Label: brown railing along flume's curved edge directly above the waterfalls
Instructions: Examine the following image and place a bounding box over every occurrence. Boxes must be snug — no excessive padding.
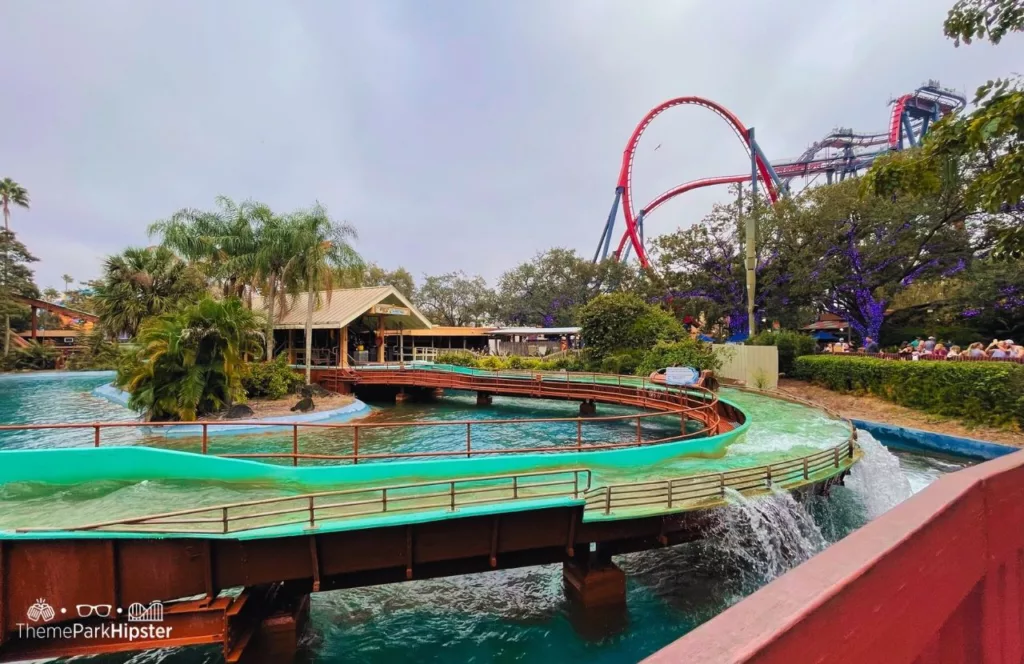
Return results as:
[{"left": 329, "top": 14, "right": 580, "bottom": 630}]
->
[{"left": 585, "top": 435, "right": 856, "bottom": 514}]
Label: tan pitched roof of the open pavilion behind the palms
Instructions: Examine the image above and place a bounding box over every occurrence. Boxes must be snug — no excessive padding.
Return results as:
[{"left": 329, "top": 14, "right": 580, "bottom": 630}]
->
[{"left": 253, "top": 286, "right": 430, "bottom": 330}]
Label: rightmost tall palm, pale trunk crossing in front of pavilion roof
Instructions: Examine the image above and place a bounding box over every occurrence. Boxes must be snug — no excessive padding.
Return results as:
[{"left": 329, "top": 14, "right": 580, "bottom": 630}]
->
[{"left": 290, "top": 203, "right": 362, "bottom": 384}]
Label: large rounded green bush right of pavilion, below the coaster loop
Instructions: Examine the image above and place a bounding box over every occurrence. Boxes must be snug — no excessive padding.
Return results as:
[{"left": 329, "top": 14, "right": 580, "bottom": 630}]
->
[{"left": 579, "top": 293, "right": 686, "bottom": 362}]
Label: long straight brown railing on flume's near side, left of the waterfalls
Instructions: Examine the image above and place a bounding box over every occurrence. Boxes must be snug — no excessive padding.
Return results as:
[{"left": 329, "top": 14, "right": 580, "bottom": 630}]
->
[{"left": 16, "top": 468, "right": 591, "bottom": 534}]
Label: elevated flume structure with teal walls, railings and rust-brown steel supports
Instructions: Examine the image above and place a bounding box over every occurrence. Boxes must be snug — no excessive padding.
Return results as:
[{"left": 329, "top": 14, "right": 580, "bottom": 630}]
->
[{"left": 0, "top": 367, "right": 860, "bottom": 662}]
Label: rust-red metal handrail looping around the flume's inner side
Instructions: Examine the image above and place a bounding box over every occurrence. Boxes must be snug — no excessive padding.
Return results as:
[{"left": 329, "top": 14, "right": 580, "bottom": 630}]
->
[{"left": 0, "top": 369, "right": 722, "bottom": 466}]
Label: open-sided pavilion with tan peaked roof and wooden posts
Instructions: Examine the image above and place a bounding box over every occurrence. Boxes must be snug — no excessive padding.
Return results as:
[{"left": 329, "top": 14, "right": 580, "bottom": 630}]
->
[{"left": 253, "top": 286, "right": 431, "bottom": 368}]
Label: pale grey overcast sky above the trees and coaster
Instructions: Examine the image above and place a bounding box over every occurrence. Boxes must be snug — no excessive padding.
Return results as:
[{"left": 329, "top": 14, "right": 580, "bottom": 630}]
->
[{"left": 0, "top": 0, "right": 1024, "bottom": 288}]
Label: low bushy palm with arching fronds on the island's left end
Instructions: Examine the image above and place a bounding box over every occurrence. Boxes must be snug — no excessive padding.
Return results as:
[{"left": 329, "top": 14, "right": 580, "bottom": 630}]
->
[{"left": 115, "top": 297, "right": 263, "bottom": 420}]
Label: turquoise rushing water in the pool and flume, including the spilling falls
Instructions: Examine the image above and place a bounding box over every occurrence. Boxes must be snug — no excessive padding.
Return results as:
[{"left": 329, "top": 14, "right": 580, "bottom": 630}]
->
[{"left": 0, "top": 376, "right": 967, "bottom": 664}]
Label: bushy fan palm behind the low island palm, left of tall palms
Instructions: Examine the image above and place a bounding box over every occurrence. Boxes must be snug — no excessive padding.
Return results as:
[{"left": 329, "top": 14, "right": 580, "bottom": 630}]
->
[{"left": 94, "top": 246, "right": 206, "bottom": 337}]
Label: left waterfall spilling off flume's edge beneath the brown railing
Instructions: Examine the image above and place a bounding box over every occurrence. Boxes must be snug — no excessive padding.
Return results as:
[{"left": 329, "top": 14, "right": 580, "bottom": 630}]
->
[{"left": 706, "top": 489, "right": 827, "bottom": 588}]
